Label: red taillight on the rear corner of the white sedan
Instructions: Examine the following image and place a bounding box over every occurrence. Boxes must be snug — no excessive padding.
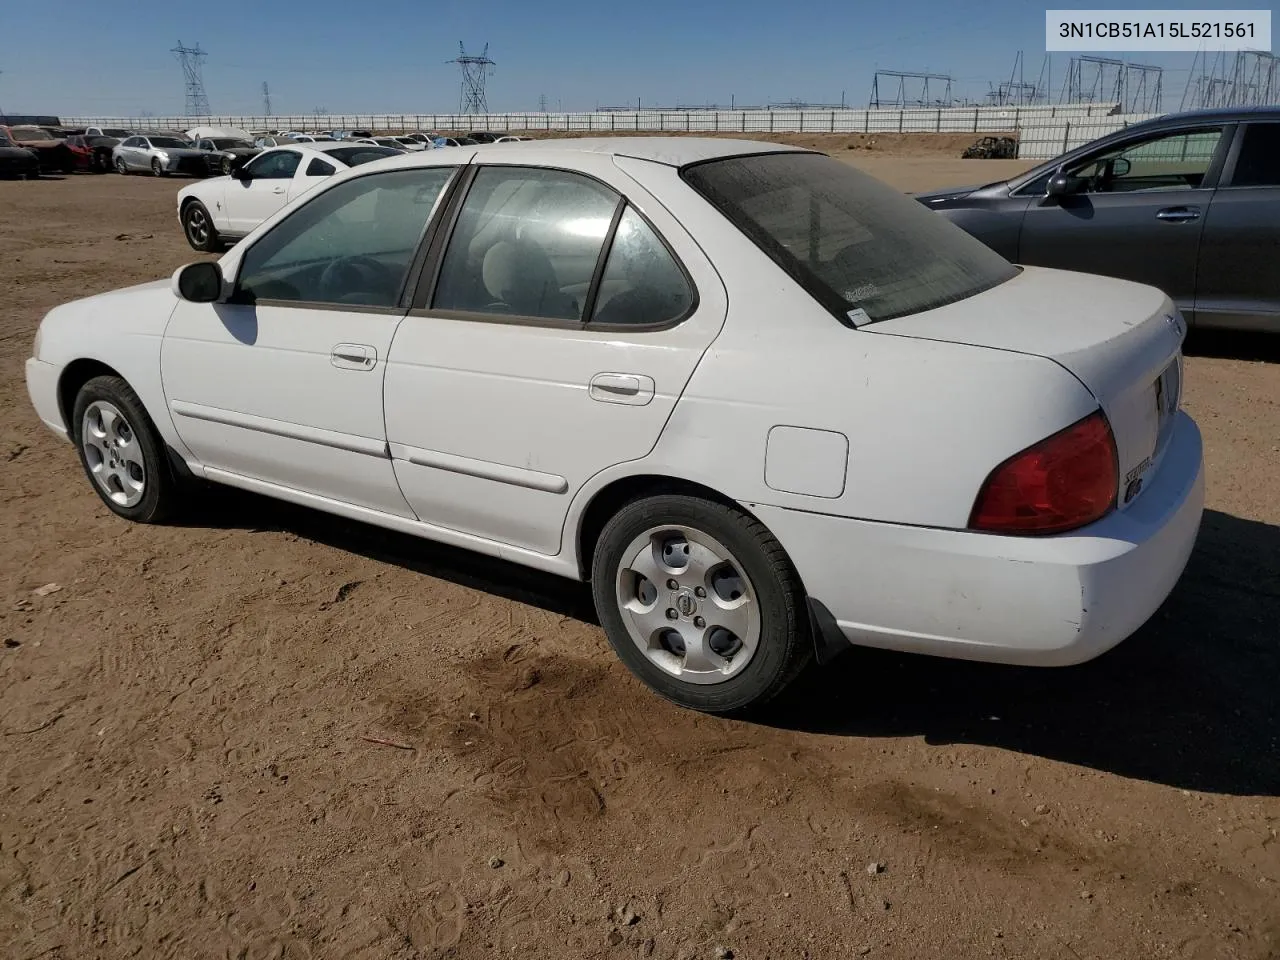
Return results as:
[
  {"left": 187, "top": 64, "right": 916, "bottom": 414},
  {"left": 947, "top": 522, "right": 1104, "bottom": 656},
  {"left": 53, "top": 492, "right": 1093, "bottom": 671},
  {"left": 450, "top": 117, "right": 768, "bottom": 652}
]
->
[{"left": 969, "top": 410, "right": 1119, "bottom": 534}]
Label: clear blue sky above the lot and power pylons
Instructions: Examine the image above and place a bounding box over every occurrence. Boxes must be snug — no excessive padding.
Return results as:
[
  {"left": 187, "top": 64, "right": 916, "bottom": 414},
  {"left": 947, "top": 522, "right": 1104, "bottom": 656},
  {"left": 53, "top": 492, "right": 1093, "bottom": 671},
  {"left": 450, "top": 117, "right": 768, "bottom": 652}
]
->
[{"left": 0, "top": 0, "right": 1247, "bottom": 116}]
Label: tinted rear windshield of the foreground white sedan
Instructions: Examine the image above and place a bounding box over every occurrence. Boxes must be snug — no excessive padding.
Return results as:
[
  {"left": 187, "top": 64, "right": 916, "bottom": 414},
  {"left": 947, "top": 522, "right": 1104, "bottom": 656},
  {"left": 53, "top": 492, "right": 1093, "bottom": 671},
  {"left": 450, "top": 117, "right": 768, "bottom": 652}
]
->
[{"left": 682, "top": 152, "right": 1018, "bottom": 326}]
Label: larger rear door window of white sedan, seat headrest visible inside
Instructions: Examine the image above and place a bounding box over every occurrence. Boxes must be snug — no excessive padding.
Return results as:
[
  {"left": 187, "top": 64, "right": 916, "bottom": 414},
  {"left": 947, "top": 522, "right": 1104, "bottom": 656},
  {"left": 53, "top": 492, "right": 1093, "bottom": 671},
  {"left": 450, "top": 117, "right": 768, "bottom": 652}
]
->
[{"left": 431, "top": 166, "right": 618, "bottom": 321}]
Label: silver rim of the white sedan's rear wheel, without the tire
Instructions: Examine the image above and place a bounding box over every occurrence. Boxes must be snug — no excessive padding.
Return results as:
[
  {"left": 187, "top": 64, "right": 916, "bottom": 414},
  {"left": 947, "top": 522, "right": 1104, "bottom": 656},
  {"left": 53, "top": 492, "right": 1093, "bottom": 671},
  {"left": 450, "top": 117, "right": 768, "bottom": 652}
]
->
[{"left": 617, "top": 526, "right": 760, "bottom": 684}]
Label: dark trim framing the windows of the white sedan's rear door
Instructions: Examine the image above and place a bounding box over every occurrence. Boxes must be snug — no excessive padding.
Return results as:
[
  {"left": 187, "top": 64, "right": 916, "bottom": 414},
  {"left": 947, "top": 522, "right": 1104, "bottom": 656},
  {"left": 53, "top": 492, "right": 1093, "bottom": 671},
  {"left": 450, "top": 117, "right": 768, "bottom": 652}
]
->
[{"left": 408, "top": 163, "right": 701, "bottom": 333}]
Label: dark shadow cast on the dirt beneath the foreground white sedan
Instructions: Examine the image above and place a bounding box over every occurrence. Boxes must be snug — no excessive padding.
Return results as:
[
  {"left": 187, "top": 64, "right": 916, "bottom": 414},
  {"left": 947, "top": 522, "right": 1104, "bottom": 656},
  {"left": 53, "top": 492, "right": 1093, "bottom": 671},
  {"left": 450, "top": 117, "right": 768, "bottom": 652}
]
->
[{"left": 185, "top": 490, "right": 1280, "bottom": 796}]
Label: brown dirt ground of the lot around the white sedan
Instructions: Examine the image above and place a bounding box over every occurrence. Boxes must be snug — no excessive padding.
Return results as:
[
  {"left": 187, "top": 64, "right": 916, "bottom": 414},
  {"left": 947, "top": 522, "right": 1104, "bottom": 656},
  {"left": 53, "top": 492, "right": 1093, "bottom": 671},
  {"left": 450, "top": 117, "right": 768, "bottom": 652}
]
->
[{"left": 0, "top": 140, "right": 1280, "bottom": 960}]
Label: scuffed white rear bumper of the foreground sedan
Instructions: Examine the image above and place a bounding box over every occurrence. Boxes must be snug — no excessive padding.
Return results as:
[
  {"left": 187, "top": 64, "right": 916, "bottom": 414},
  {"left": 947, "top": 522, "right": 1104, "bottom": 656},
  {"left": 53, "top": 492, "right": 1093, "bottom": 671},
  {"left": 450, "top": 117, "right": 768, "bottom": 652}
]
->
[{"left": 755, "top": 413, "right": 1204, "bottom": 667}]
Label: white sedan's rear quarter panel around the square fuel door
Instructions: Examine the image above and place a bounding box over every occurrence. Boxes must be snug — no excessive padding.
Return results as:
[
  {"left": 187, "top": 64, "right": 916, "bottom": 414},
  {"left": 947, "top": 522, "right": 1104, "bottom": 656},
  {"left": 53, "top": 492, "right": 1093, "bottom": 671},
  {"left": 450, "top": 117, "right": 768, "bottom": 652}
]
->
[{"left": 579, "top": 159, "right": 1097, "bottom": 527}]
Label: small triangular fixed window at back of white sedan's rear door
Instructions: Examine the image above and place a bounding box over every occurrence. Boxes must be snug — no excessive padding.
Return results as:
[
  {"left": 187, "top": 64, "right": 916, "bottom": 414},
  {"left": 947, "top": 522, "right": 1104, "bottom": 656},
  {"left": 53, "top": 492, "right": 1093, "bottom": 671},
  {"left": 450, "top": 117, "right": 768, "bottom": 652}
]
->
[{"left": 591, "top": 207, "right": 694, "bottom": 326}]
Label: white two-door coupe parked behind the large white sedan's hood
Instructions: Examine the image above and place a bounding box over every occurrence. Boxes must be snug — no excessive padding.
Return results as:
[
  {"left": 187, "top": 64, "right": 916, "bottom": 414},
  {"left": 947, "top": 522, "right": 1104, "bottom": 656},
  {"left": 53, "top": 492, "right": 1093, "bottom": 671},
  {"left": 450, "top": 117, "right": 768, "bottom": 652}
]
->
[{"left": 178, "top": 142, "right": 398, "bottom": 252}]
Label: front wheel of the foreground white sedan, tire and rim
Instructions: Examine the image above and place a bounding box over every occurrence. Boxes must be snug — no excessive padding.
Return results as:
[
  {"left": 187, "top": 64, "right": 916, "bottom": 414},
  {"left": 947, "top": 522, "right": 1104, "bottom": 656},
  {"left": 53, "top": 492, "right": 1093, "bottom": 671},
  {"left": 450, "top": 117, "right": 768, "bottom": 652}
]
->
[{"left": 72, "top": 376, "right": 179, "bottom": 524}]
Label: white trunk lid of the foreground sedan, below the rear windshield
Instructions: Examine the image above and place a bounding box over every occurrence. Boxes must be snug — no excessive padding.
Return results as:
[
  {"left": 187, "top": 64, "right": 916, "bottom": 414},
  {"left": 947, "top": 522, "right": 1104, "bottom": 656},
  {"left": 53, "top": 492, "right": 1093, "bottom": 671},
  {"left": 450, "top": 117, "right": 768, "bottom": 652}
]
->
[{"left": 861, "top": 266, "right": 1187, "bottom": 509}]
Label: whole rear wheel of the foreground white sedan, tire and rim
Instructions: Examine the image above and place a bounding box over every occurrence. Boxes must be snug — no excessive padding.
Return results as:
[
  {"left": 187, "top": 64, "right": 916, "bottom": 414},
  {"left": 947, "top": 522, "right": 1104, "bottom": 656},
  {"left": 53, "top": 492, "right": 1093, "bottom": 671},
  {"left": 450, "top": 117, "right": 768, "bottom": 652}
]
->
[{"left": 591, "top": 494, "right": 813, "bottom": 713}]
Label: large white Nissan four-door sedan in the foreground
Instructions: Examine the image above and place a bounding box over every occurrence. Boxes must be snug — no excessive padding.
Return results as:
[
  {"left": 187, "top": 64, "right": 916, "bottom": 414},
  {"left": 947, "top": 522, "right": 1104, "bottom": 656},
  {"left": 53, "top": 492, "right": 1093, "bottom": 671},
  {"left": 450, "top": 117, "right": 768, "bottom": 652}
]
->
[{"left": 27, "top": 138, "right": 1203, "bottom": 712}]
